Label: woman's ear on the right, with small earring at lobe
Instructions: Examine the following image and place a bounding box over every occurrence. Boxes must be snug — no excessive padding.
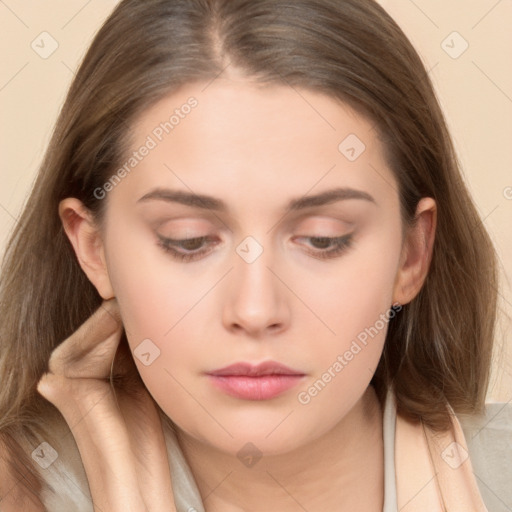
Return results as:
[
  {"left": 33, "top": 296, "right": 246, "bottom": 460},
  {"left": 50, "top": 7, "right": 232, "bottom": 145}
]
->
[{"left": 393, "top": 197, "right": 437, "bottom": 304}]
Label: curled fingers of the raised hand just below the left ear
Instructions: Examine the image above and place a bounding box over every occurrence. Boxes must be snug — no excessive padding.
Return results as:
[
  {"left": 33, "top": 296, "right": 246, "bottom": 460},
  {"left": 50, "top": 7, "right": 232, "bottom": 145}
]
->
[{"left": 49, "top": 298, "right": 122, "bottom": 378}]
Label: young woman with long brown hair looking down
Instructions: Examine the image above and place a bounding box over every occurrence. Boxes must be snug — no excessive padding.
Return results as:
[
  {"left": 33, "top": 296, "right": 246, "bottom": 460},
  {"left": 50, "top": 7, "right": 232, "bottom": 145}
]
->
[{"left": 0, "top": 0, "right": 512, "bottom": 512}]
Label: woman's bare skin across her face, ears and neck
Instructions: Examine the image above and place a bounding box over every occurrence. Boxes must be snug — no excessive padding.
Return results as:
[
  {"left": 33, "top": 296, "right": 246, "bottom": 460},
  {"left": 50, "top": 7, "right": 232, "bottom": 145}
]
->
[{"left": 59, "top": 78, "right": 436, "bottom": 512}]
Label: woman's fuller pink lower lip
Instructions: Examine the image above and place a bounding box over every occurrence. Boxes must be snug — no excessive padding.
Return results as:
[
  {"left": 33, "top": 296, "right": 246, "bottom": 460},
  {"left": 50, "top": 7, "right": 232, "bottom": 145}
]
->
[{"left": 208, "top": 375, "right": 304, "bottom": 400}]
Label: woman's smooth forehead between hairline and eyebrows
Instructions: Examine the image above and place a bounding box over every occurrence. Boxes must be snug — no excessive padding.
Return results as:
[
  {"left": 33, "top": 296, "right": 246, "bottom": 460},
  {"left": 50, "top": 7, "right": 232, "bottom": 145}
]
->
[{"left": 117, "top": 78, "right": 397, "bottom": 215}]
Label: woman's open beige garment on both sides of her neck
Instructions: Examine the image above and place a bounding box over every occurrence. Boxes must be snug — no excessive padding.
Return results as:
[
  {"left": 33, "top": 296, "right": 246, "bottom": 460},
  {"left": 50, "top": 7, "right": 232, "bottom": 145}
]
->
[{"left": 34, "top": 393, "right": 512, "bottom": 512}]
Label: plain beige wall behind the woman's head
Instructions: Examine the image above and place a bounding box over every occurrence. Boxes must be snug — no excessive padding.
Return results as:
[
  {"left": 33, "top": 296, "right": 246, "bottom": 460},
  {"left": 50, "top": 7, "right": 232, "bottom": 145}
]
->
[{"left": 0, "top": 0, "right": 512, "bottom": 401}]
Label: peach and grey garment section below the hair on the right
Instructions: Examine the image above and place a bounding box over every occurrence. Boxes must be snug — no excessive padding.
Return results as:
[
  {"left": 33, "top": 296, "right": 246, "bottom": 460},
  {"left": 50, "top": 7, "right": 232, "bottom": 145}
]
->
[{"left": 395, "top": 388, "right": 512, "bottom": 512}]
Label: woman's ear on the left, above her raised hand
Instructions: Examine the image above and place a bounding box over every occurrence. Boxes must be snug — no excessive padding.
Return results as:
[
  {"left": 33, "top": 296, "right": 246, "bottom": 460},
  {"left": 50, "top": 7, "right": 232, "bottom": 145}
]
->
[{"left": 59, "top": 197, "right": 115, "bottom": 300}]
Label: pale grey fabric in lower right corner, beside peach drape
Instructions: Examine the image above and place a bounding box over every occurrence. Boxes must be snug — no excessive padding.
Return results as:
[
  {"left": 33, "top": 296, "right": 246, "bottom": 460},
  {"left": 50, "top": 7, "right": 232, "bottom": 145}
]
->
[{"left": 458, "top": 402, "right": 512, "bottom": 511}]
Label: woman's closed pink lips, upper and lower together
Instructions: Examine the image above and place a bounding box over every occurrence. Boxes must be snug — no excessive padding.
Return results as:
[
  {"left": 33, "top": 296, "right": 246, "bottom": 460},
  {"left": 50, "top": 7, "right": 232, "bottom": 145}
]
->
[{"left": 207, "top": 361, "right": 305, "bottom": 400}]
